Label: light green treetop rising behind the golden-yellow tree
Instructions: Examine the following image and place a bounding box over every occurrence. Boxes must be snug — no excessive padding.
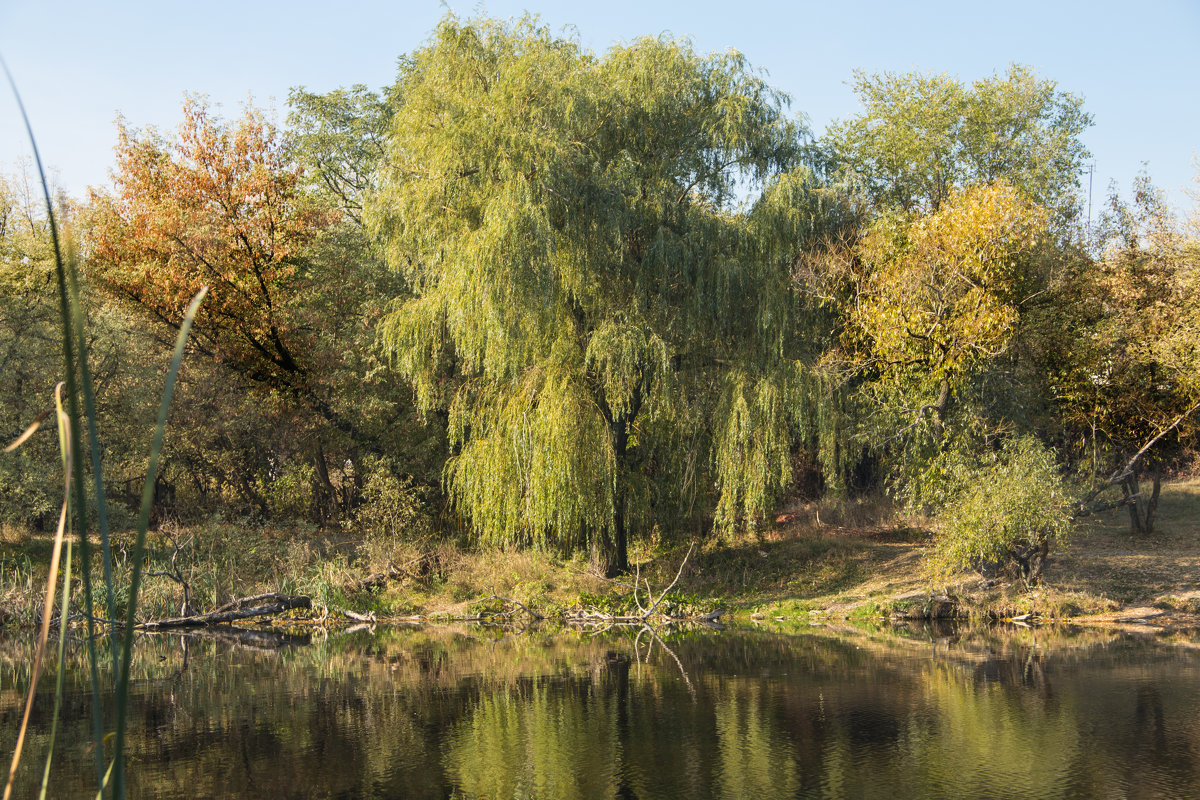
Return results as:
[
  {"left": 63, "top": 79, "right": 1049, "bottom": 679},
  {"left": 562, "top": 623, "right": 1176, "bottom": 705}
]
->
[{"left": 826, "top": 65, "right": 1092, "bottom": 222}]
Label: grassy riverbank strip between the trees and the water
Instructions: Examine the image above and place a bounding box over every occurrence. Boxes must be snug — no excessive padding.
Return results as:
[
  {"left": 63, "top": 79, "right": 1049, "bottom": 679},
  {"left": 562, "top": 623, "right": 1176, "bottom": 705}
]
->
[{"left": 0, "top": 479, "right": 1200, "bottom": 630}]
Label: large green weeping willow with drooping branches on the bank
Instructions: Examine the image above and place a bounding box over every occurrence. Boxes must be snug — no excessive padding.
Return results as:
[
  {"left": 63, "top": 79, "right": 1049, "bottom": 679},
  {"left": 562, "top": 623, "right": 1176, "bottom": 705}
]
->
[{"left": 367, "top": 17, "right": 820, "bottom": 573}]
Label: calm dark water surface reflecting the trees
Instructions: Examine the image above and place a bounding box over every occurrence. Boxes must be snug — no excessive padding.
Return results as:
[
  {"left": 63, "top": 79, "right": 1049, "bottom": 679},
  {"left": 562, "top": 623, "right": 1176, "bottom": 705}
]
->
[{"left": 0, "top": 627, "right": 1200, "bottom": 800}]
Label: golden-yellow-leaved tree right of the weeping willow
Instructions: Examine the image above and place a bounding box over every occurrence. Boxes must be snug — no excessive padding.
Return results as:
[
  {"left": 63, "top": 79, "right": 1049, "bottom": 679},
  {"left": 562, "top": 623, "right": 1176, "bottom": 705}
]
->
[{"left": 847, "top": 184, "right": 1046, "bottom": 503}]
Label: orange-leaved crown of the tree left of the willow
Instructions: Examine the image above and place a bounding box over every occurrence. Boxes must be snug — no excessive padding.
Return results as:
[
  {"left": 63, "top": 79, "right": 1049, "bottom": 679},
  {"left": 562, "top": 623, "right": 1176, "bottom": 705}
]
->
[{"left": 89, "top": 98, "right": 337, "bottom": 401}]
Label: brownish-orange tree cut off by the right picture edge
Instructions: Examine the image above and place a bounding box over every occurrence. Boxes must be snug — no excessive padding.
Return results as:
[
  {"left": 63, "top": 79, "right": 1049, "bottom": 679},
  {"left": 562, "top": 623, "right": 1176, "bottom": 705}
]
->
[{"left": 1054, "top": 175, "right": 1200, "bottom": 533}]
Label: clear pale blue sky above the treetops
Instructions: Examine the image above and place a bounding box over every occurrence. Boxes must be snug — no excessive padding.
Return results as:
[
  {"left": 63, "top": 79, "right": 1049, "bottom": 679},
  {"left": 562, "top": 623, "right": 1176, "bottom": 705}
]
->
[{"left": 0, "top": 0, "right": 1200, "bottom": 214}]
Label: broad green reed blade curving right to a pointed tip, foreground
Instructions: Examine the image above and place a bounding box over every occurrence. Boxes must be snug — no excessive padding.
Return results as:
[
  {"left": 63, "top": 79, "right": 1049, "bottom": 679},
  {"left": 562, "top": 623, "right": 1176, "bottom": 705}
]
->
[{"left": 113, "top": 287, "right": 209, "bottom": 798}]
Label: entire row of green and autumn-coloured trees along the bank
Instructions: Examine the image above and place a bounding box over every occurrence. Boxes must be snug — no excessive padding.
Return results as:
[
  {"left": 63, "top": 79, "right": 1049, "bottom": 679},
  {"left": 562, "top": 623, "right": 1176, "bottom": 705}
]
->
[{"left": 0, "top": 17, "right": 1200, "bottom": 579}]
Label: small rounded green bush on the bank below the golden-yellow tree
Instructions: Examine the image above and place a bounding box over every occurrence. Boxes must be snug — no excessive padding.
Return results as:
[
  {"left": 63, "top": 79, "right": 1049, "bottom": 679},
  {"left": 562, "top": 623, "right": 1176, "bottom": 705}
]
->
[{"left": 932, "top": 435, "right": 1070, "bottom": 585}]
